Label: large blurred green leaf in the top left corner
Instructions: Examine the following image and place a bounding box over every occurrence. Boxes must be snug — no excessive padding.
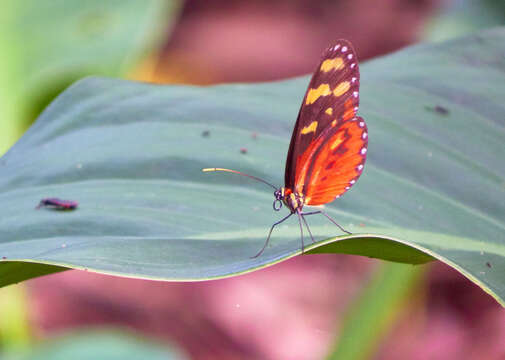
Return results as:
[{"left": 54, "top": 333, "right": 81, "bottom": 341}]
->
[{"left": 0, "top": 0, "right": 179, "bottom": 153}]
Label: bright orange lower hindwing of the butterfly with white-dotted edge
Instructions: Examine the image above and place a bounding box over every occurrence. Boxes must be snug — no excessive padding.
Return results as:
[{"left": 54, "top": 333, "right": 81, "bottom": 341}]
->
[{"left": 295, "top": 116, "right": 368, "bottom": 205}]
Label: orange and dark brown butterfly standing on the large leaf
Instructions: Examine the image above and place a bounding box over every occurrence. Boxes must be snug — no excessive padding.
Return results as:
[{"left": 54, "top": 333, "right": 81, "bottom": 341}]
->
[{"left": 202, "top": 39, "right": 368, "bottom": 258}]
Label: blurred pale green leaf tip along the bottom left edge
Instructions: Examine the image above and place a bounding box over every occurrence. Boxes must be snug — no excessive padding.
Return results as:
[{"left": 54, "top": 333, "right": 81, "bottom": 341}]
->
[{"left": 2, "top": 329, "right": 187, "bottom": 360}]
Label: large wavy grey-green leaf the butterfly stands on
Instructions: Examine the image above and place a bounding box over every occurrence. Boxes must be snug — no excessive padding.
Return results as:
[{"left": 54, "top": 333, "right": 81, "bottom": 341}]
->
[{"left": 0, "top": 28, "right": 505, "bottom": 304}]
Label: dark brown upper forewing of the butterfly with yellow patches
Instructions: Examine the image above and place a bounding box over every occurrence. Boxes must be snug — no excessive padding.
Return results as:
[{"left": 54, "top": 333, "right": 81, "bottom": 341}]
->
[{"left": 284, "top": 40, "right": 359, "bottom": 188}]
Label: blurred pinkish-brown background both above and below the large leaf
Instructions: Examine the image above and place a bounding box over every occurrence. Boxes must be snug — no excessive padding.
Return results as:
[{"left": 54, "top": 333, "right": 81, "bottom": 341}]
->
[{"left": 28, "top": 0, "right": 505, "bottom": 360}]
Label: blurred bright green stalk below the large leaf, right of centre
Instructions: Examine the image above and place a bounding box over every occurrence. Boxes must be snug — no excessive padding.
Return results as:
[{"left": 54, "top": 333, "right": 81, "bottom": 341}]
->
[{"left": 328, "top": 263, "right": 424, "bottom": 360}]
